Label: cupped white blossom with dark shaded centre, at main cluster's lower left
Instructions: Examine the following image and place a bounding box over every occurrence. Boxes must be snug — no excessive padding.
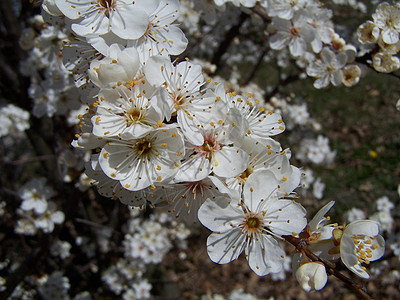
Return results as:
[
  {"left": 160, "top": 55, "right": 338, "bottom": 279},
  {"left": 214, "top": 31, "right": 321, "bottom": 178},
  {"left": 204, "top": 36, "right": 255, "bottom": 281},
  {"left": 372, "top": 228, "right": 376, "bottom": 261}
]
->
[{"left": 99, "top": 128, "right": 185, "bottom": 191}]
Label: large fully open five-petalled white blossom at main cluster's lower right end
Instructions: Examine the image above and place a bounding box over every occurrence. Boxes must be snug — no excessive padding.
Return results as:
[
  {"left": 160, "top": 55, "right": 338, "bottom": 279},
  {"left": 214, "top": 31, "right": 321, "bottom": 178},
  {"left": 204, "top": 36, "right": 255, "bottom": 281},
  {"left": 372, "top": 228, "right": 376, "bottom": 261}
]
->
[{"left": 198, "top": 170, "right": 306, "bottom": 276}]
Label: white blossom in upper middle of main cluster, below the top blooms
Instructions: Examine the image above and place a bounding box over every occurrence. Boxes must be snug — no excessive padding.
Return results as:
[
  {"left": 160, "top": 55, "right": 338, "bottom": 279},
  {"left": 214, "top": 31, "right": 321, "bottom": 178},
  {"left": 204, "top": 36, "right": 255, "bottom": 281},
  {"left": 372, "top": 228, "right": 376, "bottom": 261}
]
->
[{"left": 145, "top": 56, "right": 223, "bottom": 145}]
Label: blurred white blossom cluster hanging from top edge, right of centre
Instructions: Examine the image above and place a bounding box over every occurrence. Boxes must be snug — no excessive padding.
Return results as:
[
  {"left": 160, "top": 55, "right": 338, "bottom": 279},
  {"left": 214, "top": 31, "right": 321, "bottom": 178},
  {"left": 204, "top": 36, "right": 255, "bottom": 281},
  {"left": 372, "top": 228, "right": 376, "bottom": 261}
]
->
[{"left": 211, "top": 0, "right": 361, "bottom": 89}]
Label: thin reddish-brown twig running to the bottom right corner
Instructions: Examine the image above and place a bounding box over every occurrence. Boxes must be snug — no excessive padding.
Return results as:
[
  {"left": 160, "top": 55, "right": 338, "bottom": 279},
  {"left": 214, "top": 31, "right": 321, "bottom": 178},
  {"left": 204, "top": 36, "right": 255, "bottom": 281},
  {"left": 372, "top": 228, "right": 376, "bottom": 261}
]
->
[{"left": 283, "top": 235, "right": 371, "bottom": 300}]
